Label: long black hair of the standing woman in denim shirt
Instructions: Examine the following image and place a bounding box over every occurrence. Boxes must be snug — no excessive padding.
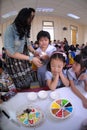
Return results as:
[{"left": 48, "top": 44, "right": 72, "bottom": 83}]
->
[{"left": 13, "top": 8, "right": 35, "bottom": 39}]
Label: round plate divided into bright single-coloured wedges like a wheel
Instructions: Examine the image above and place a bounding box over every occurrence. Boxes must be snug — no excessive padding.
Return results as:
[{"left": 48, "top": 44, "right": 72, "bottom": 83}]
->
[{"left": 50, "top": 99, "right": 73, "bottom": 119}]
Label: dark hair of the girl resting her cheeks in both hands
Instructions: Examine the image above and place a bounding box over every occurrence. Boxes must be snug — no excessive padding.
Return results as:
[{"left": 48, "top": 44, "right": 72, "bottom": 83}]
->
[{"left": 47, "top": 52, "right": 66, "bottom": 71}]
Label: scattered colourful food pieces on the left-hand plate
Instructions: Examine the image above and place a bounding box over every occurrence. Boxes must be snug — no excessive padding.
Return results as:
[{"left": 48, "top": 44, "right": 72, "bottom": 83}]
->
[{"left": 17, "top": 106, "right": 44, "bottom": 126}]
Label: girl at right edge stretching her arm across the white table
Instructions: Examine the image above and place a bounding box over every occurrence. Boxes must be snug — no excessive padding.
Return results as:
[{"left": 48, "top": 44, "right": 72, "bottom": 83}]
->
[{"left": 68, "top": 54, "right": 87, "bottom": 108}]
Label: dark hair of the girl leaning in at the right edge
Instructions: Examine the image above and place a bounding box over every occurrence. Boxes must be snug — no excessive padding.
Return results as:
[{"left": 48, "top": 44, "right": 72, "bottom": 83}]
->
[{"left": 74, "top": 54, "right": 87, "bottom": 69}]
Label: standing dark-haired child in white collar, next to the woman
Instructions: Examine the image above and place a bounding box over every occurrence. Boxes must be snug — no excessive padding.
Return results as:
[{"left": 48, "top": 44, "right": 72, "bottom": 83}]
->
[{"left": 36, "top": 31, "right": 56, "bottom": 87}]
